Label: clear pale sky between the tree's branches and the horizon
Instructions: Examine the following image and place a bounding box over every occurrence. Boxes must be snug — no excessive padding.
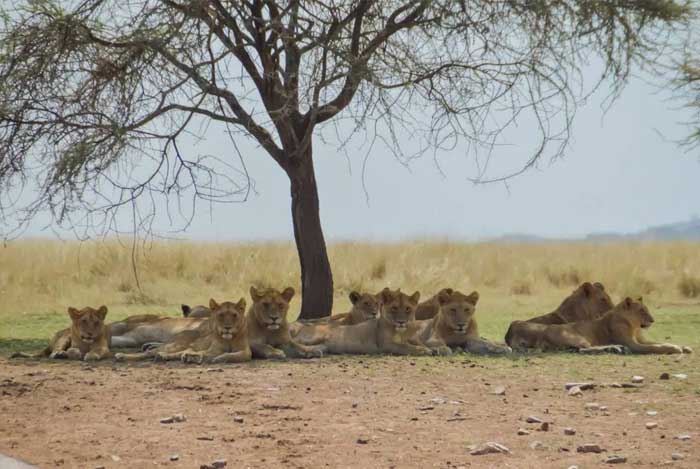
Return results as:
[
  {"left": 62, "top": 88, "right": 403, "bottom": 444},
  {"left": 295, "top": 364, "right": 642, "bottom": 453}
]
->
[{"left": 10, "top": 66, "right": 700, "bottom": 241}]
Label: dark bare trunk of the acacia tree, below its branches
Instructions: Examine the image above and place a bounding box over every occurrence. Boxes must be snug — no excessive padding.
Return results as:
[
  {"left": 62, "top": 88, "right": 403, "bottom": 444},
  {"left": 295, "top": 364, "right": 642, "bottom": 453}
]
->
[{"left": 287, "top": 146, "right": 333, "bottom": 319}]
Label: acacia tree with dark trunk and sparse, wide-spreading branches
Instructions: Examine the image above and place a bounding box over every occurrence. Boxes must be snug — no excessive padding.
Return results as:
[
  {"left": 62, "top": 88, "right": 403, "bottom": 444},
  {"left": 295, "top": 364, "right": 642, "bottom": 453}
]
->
[{"left": 0, "top": 0, "right": 689, "bottom": 318}]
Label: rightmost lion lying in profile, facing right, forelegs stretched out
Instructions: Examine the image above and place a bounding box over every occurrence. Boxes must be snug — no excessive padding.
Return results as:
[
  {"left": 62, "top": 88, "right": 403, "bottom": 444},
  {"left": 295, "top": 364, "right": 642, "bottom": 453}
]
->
[{"left": 506, "top": 297, "right": 692, "bottom": 354}]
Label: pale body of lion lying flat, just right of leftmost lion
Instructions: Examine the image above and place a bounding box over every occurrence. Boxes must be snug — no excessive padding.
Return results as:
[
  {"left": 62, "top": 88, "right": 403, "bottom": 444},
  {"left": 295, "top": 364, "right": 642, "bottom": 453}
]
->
[{"left": 110, "top": 314, "right": 206, "bottom": 348}]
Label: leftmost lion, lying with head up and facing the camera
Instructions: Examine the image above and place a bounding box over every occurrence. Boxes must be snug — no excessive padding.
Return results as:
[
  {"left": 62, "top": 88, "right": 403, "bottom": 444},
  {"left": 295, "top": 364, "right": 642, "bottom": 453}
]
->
[{"left": 12, "top": 305, "right": 112, "bottom": 361}]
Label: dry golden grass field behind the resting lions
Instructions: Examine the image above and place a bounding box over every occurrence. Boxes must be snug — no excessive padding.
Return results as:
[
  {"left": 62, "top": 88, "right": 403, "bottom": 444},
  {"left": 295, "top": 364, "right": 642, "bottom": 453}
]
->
[{"left": 0, "top": 240, "right": 700, "bottom": 354}]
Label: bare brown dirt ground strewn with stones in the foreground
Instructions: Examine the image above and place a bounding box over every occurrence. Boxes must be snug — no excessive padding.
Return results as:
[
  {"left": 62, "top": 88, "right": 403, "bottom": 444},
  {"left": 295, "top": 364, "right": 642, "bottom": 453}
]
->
[{"left": 0, "top": 354, "right": 700, "bottom": 469}]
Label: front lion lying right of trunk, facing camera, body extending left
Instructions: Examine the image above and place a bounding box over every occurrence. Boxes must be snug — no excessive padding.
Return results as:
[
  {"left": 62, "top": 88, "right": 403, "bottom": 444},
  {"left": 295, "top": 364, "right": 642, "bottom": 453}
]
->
[{"left": 322, "top": 288, "right": 433, "bottom": 355}]
